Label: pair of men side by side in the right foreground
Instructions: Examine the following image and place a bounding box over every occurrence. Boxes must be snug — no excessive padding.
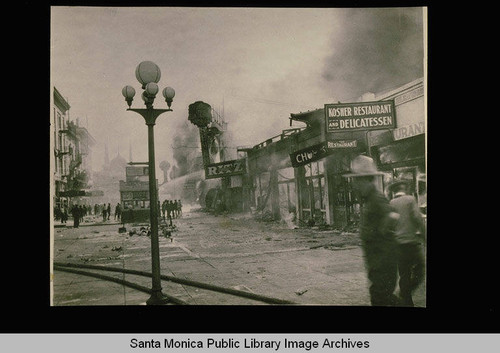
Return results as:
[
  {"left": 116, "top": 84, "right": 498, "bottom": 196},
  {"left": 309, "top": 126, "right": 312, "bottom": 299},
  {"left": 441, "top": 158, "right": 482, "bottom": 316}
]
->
[{"left": 344, "top": 155, "right": 426, "bottom": 307}]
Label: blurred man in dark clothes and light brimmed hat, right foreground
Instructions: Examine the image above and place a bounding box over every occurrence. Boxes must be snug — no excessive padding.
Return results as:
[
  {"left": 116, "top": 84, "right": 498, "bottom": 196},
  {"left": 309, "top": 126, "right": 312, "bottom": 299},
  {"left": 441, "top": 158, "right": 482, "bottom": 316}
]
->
[{"left": 343, "top": 155, "right": 399, "bottom": 306}]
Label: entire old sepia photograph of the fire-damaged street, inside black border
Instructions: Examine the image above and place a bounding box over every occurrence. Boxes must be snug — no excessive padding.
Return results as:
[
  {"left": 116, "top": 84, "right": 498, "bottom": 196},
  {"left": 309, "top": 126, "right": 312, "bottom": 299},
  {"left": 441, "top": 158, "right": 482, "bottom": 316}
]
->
[{"left": 48, "top": 6, "right": 428, "bottom": 310}]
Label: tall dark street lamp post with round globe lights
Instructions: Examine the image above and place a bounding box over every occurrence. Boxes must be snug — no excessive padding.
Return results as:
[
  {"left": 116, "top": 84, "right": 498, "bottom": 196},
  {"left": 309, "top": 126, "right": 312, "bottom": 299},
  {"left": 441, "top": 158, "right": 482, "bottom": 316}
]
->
[{"left": 122, "top": 61, "right": 175, "bottom": 305}]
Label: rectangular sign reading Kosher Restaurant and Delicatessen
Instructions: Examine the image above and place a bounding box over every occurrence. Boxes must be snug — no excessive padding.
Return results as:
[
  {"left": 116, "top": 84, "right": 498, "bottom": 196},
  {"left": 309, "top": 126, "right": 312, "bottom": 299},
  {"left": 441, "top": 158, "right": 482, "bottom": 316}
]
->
[{"left": 325, "top": 100, "right": 396, "bottom": 132}]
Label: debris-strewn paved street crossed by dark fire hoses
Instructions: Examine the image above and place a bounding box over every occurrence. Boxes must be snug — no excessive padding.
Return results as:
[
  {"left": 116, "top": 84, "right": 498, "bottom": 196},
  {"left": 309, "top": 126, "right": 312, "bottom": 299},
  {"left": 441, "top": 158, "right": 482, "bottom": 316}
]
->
[{"left": 53, "top": 210, "right": 425, "bottom": 307}]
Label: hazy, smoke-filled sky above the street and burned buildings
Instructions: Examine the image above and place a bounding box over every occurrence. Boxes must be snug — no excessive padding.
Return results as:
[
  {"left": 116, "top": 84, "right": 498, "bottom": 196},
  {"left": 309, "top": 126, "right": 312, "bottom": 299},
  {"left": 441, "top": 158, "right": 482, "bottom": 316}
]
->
[{"left": 50, "top": 6, "right": 425, "bottom": 175}]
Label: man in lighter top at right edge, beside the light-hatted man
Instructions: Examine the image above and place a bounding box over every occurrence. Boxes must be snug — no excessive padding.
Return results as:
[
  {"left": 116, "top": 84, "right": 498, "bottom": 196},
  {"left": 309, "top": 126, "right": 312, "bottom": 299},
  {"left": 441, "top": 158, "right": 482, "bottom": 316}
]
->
[{"left": 389, "top": 180, "right": 425, "bottom": 306}]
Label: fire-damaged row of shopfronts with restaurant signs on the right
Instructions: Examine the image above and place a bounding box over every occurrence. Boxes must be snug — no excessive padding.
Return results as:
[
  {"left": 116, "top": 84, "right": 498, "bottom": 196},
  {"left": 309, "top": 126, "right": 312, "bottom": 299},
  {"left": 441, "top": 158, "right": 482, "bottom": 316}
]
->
[{"left": 240, "top": 79, "right": 427, "bottom": 227}]
